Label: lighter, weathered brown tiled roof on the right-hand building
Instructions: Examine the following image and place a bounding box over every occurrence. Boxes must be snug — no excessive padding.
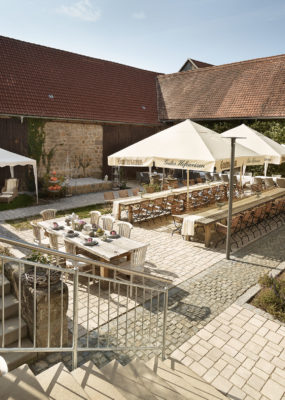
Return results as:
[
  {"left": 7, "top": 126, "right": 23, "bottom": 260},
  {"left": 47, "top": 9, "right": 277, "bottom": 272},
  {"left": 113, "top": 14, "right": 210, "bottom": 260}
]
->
[{"left": 158, "top": 55, "right": 285, "bottom": 121}]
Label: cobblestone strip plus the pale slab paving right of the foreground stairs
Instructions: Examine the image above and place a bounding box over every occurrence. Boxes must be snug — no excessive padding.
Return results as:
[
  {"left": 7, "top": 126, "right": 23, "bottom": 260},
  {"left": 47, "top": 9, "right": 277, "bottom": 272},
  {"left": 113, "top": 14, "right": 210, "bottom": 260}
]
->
[{"left": 27, "top": 226, "right": 285, "bottom": 400}]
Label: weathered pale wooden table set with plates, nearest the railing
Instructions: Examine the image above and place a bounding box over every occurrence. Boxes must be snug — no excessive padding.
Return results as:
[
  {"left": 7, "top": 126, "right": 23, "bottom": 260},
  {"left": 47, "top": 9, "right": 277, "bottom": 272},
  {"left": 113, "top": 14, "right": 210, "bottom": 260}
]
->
[{"left": 38, "top": 217, "right": 145, "bottom": 277}]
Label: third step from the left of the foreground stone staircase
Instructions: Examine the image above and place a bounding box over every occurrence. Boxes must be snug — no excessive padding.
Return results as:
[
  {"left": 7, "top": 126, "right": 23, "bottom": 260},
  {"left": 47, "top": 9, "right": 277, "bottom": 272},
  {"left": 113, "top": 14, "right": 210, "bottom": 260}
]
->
[{"left": 71, "top": 361, "right": 126, "bottom": 400}]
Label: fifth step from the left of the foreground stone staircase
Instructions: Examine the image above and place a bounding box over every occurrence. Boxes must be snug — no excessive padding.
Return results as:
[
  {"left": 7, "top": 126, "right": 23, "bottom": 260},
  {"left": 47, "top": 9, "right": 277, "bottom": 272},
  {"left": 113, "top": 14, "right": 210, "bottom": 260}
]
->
[{"left": 127, "top": 359, "right": 186, "bottom": 400}]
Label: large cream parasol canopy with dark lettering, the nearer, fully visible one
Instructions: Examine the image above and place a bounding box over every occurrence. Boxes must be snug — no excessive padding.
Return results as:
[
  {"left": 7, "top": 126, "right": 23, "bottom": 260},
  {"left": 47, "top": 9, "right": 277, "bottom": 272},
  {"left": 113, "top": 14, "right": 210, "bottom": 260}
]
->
[{"left": 108, "top": 119, "right": 264, "bottom": 172}]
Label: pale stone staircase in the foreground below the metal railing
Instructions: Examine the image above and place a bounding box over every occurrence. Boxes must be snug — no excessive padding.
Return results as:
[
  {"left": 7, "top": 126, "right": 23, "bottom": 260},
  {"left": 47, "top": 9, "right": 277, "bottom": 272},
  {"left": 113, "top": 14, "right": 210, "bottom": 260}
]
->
[{"left": 0, "top": 358, "right": 227, "bottom": 400}]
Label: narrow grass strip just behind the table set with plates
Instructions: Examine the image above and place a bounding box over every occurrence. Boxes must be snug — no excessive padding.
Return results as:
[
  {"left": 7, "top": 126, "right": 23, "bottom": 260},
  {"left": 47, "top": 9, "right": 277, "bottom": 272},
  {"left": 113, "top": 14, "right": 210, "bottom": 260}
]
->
[{"left": 7, "top": 204, "right": 110, "bottom": 231}]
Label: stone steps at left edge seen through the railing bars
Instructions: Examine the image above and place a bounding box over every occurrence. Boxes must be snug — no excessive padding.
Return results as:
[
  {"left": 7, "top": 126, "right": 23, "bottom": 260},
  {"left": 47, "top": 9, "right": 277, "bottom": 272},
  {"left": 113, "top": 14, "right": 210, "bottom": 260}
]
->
[{"left": 0, "top": 275, "right": 36, "bottom": 371}]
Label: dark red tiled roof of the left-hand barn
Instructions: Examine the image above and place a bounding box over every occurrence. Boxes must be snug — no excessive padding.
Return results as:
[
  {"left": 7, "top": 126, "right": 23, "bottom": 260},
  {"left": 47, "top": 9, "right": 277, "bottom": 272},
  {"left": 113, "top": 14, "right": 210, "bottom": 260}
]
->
[{"left": 0, "top": 36, "right": 158, "bottom": 124}]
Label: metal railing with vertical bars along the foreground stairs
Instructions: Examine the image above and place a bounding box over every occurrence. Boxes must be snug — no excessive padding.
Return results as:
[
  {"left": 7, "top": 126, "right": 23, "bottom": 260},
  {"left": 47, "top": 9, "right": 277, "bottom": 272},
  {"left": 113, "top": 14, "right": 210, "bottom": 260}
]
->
[{"left": 0, "top": 237, "right": 171, "bottom": 369}]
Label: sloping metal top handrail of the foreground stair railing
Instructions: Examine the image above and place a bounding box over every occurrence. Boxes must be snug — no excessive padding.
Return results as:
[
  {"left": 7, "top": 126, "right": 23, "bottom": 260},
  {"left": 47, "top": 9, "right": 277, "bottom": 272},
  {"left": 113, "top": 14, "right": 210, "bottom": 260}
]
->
[{"left": 0, "top": 236, "right": 173, "bottom": 285}]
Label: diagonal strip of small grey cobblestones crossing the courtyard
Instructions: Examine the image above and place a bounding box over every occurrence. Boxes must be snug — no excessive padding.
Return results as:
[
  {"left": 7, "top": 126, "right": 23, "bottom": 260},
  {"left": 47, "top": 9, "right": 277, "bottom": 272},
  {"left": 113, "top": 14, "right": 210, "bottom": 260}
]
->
[{"left": 28, "top": 223, "right": 285, "bottom": 382}]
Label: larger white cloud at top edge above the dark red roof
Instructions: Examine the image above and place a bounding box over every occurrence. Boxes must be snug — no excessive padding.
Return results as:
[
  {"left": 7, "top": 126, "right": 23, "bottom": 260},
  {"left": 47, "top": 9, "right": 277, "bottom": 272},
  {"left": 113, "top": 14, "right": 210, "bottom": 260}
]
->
[{"left": 56, "top": 0, "right": 101, "bottom": 22}]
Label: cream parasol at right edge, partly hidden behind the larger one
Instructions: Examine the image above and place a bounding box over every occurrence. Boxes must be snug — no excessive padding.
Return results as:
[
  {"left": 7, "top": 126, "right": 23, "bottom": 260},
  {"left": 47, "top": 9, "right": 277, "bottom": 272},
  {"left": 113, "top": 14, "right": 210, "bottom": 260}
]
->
[{"left": 223, "top": 124, "right": 285, "bottom": 176}]
